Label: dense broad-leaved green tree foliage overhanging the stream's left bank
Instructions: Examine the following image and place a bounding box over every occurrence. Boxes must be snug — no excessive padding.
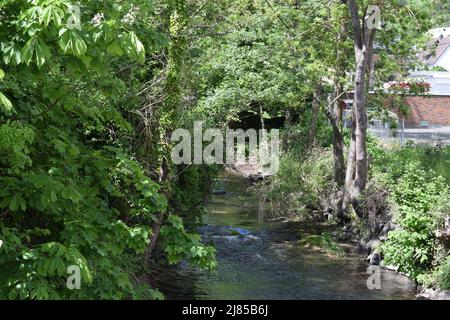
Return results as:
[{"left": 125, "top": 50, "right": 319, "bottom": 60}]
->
[{"left": 0, "top": 0, "right": 214, "bottom": 299}]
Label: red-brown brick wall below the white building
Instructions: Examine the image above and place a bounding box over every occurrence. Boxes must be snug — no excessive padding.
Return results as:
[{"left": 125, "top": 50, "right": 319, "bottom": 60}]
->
[{"left": 405, "top": 96, "right": 450, "bottom": 126}]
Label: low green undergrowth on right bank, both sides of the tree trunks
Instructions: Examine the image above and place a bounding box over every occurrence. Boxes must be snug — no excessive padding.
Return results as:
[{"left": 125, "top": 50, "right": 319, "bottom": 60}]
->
[{"left": 260, "top": 140, "right": 450, "bottom": 290}]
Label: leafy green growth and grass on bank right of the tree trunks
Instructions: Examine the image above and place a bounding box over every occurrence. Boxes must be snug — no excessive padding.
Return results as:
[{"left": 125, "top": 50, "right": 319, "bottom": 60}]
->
[{"left": 371, "top": 146, "right": 450, "bottom": 283}]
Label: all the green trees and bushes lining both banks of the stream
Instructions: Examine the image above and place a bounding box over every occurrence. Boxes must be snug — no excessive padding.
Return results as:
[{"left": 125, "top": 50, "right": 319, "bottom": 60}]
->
[{"left": 0, "top": 0, "right": 450, "bottom": 299}]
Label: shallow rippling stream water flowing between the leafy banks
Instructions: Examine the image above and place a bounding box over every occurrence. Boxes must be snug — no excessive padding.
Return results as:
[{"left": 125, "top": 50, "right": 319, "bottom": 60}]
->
[{"left": 153, "top": 176, "right": 414, "bottom": 300}]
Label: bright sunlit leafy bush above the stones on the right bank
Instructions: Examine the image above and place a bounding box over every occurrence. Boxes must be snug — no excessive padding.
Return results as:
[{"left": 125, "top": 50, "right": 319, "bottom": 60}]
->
[{"left": 382, "top": 162, "right": 449, "bottom": 279}]
